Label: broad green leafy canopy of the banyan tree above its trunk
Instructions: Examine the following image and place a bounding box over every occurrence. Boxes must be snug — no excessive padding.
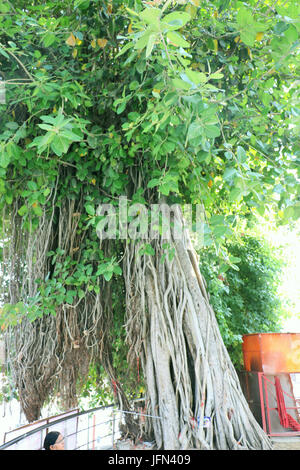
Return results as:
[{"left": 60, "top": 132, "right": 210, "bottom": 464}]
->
[{"left": 0, "top": 1, "right": 299, "bottom": 326}]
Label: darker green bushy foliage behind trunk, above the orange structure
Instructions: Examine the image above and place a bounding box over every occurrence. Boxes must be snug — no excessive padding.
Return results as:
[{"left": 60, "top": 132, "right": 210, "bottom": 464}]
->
[{"left": 201, "top": 234, "right": 286, "bottom": 369}]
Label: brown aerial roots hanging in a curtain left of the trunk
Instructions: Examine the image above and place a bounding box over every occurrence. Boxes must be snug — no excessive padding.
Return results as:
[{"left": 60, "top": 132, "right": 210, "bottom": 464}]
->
[{"left": 2, "top": 178, "right": 115, "bottom": 421}]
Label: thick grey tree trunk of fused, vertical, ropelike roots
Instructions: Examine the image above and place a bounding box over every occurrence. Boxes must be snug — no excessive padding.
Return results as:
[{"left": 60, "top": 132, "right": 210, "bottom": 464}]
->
[{"left": 124, "top": 207, "right": 272, "bottom": 450}]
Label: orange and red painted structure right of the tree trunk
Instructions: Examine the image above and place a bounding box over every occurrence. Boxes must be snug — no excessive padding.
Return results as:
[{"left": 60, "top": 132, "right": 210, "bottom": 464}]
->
[{"left": 243, "top": 333, "right": 300, "bottom": 436}]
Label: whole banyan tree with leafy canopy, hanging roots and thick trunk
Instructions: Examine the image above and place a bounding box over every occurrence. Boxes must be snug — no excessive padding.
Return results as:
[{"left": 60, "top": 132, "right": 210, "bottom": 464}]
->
[{"left": 0, "top": 0, "right": 299, "bottom": 450}]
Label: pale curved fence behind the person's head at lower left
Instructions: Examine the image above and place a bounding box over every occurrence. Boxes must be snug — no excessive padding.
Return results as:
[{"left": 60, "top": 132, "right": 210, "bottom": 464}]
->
[{"left": 0, "top": 405, "right": 161, "bottom": 450}]
